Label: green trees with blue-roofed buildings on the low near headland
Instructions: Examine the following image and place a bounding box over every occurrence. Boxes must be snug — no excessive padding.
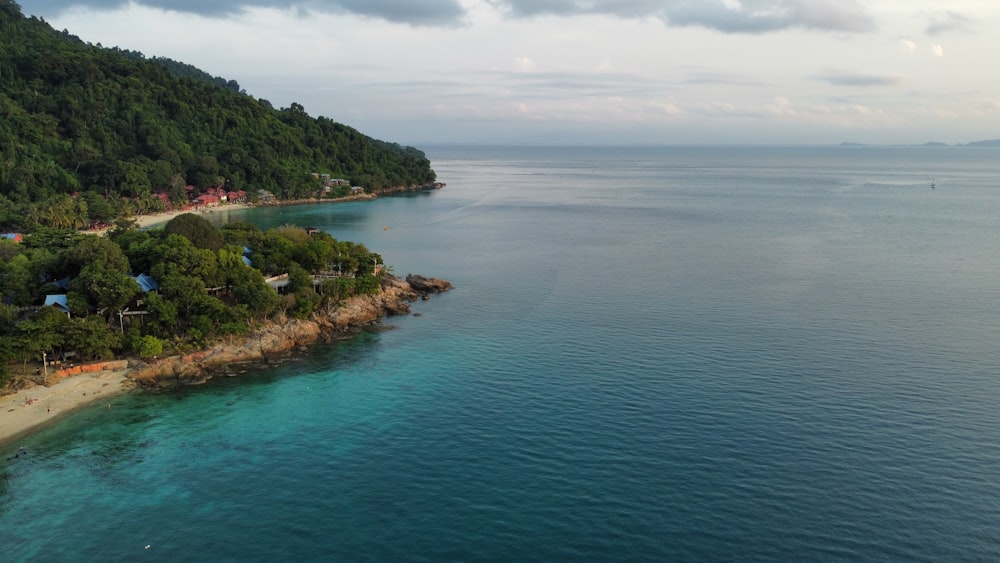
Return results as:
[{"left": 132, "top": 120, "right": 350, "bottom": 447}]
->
[{"left": 0, "top": 214, "right": 384, "bottom": 383}]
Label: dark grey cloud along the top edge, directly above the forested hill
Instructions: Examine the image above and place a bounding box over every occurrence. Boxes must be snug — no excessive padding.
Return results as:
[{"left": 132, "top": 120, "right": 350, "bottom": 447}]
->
[{"left": 20, "top": 0, "right": 465, "bottom": 25}]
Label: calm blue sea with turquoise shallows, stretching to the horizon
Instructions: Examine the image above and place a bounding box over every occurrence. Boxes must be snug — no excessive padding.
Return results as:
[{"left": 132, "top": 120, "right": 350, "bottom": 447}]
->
[{"left": 0, "top": 147, "right": 1000, "bottom": 561}]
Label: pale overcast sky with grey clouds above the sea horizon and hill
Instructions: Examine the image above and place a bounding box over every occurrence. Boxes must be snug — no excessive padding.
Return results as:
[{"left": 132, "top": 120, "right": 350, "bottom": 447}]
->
[{"left": 19, "top": 0, "right": 1000, "bottom": 146}]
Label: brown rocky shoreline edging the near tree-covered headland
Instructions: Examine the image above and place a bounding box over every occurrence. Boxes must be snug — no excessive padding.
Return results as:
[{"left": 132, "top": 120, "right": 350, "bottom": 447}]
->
[{"left": 128, "top": 274, "right": 452, "bottom": 388}]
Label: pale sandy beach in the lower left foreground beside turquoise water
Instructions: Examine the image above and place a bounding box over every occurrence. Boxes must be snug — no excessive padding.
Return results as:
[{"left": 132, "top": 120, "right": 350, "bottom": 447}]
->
[{"left": 0, "top": 370, "right": 132, "bottom": 447}]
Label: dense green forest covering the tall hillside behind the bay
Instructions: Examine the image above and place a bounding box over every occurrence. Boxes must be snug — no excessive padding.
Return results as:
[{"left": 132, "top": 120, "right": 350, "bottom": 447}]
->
[{"left": 0, "top": 0, "right": 435, "bottom": 233}]
